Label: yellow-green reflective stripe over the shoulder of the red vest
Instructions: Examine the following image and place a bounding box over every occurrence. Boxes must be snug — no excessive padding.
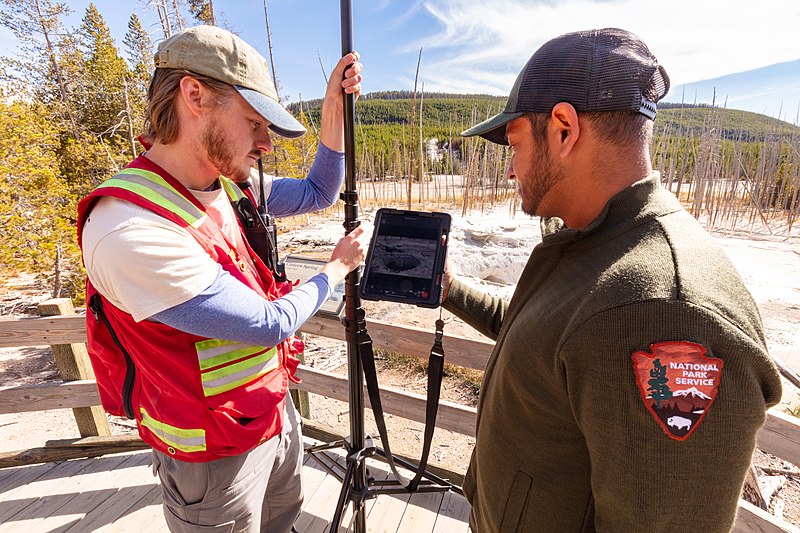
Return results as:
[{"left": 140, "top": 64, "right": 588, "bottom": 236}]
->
[{"left": 98, "top": 168, "right": 205, "bottom": 228}]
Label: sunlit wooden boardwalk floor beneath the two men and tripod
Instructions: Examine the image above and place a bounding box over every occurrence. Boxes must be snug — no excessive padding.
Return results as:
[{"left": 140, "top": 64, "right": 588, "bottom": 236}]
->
[{"left": 0, "top": 440, "right": 469, "bottom": 533}]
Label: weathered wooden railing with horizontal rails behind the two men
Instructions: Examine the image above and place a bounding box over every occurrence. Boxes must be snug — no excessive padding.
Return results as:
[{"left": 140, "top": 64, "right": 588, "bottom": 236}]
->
[{"left": 0, "top": 299, "right": 800, "bottom": 532}]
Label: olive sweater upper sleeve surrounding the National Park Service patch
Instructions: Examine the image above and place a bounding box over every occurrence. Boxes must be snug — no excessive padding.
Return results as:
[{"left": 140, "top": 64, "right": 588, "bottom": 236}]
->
[{"left": 558, "top": 301, "right": 781, "bottom": 532}]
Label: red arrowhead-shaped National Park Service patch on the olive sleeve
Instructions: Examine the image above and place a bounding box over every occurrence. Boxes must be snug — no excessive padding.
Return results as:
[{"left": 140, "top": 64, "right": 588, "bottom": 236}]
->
[{"left": 633, "top": 341, "right": 722, "bottom": 440}]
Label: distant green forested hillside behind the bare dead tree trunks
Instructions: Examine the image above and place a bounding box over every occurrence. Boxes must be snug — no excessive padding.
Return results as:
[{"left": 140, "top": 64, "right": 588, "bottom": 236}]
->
[{"left": 291, "top": 91, "right": 800, "bottom": 195}]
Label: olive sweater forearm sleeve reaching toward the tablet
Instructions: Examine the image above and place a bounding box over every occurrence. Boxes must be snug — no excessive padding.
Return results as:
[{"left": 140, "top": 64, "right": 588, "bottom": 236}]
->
[{"left": 442, "top": 278, "right": 508, "bottom": 340}]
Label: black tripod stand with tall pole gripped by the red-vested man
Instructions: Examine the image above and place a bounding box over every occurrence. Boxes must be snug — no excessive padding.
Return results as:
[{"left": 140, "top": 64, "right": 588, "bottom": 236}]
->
[{"left": 307, "top": 0, "right": 461, "bottom": 533}]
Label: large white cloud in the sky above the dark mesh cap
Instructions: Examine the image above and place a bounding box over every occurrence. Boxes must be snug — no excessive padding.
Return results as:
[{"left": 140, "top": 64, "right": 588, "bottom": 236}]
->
[{"left": 408, "top": 0, "right": 800, "bottom": 94}]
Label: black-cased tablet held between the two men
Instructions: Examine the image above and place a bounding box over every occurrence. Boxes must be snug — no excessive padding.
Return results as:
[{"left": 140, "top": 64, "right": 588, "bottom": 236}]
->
[{"left": 359, "top": 208, "right": 450, "bottom": 307}]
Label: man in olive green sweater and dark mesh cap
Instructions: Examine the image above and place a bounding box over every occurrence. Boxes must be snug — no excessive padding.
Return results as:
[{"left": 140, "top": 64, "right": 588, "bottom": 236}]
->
[{"left": 445, "top": 29, "right": 781, "bottom": 533}]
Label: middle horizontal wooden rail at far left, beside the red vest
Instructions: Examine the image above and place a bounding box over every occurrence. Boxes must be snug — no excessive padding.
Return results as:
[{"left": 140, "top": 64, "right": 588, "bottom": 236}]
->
[{"left": 0, "top": 380, "right": 100, "bottom": 414}]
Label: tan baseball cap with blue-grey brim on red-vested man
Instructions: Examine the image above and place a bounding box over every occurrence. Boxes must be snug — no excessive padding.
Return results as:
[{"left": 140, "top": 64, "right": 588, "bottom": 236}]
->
[{"left": 154, "top": 26, "right": 306, "bottom": 137}]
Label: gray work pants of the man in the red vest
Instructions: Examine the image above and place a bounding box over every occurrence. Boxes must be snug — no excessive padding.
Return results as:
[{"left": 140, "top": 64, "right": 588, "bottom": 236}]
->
[{"left": 153, "top": 394, "right": 303, "bottom": 533}]
